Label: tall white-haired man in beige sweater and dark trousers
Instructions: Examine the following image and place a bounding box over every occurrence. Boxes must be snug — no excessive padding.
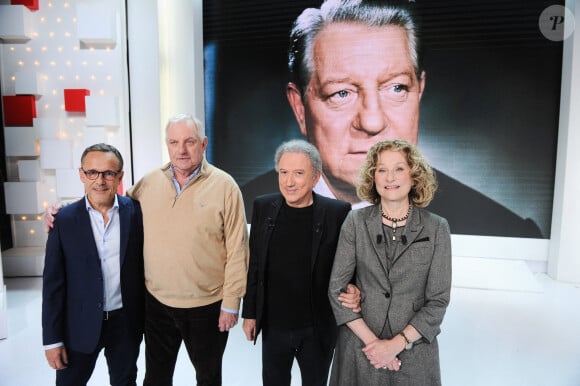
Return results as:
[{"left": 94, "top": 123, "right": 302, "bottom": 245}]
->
[{"left": 127, "top": 115, "right": 249, "bottom": 386}]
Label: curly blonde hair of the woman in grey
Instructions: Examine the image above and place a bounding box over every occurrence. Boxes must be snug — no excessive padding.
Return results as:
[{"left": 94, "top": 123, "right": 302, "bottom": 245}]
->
[{"left": 356, "top": 139, "right": 437, "bottom": 208}]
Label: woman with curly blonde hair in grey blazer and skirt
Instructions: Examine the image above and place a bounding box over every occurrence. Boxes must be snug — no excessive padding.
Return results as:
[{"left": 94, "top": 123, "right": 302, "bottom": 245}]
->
[{"left": 329, "top": 140, "right": 451, "bottom": 386}]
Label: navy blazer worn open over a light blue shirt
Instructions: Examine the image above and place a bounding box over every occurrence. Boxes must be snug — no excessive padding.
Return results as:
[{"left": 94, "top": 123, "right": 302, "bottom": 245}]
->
[{"left": 42, "top": 196, "right": 145, "bottom": 353}]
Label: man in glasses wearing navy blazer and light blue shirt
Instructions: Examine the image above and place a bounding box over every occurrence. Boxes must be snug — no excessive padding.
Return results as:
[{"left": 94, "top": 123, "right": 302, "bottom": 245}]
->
[{"left": 42, "top": 144, "right": 144, "bottom": 386}]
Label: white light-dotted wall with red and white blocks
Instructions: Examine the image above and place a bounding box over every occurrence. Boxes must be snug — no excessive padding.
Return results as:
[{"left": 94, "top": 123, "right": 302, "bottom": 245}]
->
[{"left": 0, "top": 0, "right": 133, "bottom": 276}]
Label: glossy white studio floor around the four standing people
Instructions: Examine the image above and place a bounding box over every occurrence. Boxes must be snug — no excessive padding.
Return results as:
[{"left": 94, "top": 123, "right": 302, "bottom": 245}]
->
[{"left": 0, "top": 259, "right": 580, "bottom": 386}]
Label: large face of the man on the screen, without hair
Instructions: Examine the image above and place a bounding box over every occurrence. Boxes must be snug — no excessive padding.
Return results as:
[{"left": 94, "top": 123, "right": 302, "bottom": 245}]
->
[{"left": 288, "top": 23, "right": 425, "bottom": 202}]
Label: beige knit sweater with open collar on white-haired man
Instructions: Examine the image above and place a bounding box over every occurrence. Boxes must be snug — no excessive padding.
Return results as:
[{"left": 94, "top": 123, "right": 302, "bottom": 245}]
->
[{"left": 127, "top": 159, "right": 249, "bottom": 310}]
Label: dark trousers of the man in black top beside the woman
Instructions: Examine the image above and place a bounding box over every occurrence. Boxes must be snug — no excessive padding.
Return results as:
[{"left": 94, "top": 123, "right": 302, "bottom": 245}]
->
[{"left": 262, "top": 326, "right": 334, "bottom": 386}]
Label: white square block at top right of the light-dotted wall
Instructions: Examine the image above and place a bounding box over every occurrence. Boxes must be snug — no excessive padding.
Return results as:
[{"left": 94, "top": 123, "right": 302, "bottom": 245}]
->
[{"left": 76, "top": 4, "right": 117, "bottom": 49}]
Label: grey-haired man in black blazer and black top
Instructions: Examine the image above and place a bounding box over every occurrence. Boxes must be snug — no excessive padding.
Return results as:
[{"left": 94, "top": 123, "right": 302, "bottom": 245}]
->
[{"left": 242, "top": 140, "right": 360, "bottom": 386}]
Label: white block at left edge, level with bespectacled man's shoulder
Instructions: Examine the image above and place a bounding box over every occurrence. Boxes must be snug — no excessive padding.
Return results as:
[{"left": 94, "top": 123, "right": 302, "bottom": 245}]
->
[{"left": 4, "top": 182, "right": 44, "bottom": 214}]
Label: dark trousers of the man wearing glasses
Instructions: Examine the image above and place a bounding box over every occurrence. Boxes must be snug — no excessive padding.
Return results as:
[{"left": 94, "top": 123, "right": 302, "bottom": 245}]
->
[{"left": 56, "top": 310, "right": 143, "bottom": 386}]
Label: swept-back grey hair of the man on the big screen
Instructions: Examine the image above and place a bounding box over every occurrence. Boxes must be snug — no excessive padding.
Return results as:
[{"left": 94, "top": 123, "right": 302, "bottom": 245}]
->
[{"left": 288, "top": 0, "right": 421, "bottom": 95}]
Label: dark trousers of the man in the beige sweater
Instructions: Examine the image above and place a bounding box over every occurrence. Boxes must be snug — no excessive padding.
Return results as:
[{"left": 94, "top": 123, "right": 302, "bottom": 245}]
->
[{"left": 143, "top": 292, "right": 228, "bottom": 386}]
